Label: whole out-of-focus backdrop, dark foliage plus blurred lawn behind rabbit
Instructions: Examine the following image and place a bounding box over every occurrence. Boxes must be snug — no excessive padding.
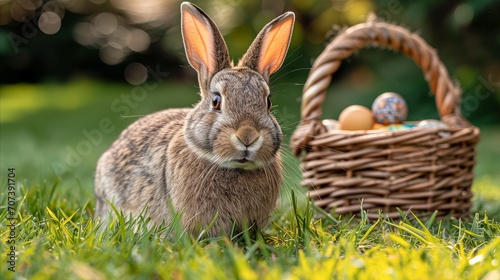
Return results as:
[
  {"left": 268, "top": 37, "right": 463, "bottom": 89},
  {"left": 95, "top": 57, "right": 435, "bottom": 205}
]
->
[{"left": 0, "top": 0, "right": 500, "bottom": 214}]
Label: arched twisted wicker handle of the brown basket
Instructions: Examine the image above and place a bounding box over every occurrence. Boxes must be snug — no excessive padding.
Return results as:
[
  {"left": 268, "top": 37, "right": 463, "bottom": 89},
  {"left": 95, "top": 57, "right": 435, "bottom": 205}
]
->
[{"left": 291, "top": 15, "right": 470, "bottom": 155}]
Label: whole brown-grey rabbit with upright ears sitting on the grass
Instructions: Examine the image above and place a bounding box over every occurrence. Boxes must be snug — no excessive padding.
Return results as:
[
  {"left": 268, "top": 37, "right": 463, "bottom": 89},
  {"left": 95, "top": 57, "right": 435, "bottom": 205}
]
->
[{"left": 94, "top": 2, "right": 295, "bottom": 237}]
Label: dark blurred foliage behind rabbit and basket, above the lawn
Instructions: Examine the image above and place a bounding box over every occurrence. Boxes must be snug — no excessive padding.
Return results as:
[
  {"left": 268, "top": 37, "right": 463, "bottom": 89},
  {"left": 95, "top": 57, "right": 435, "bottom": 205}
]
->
[{"left": 0, "top": 0, "right": 500, "bottom": 122}]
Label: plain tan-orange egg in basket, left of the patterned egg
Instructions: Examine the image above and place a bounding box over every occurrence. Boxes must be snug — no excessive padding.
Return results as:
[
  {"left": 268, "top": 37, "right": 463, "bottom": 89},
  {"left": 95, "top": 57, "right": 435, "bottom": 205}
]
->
[{"left": 339, "top": 105, "right": 373, "bottom": 130}]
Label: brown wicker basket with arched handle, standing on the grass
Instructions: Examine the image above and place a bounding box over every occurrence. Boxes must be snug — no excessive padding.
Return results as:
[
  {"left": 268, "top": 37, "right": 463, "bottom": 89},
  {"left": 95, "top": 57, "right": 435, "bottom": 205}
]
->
[{"left": 291, "top": 17, "right": 479, "bottom": 218}]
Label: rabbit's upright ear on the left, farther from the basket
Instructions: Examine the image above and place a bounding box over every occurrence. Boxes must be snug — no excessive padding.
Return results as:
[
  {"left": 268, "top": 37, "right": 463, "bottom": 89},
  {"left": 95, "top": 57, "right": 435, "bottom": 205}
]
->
[{"left": 181, "top": 2, "right": 231, "bottom": 91}]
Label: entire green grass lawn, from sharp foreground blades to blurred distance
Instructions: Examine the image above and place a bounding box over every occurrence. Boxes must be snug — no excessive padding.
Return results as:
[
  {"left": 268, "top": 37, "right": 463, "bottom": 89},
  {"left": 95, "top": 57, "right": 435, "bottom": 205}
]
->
[{"left": 0, "top": 80, "right": 500, "bottom": 280}]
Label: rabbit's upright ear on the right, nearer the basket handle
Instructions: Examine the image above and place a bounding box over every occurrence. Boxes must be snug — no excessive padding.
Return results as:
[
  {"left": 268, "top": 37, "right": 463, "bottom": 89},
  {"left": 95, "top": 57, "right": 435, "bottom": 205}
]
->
[{"left": 238, "top": 12, "right": 295, "bottom": 81}]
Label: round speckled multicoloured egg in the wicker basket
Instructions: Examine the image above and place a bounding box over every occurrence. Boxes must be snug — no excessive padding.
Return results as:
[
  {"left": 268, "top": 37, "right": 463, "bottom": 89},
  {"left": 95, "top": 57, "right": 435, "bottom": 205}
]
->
[{"left": 372, "top": 92, "right": 408, "bottom": 125}]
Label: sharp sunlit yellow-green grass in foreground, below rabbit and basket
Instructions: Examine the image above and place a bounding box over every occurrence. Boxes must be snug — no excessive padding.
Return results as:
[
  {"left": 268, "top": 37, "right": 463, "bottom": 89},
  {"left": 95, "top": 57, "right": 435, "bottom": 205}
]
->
[{"left": 0, "top": 180, "right": 500, "bottom": 279}]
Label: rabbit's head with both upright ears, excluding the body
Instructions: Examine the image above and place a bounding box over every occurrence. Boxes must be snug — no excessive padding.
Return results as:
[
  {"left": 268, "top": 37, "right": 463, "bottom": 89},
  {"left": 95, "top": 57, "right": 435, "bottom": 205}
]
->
[{"left": 181, "top": 2, "right": 295, "bottom": 170}]
